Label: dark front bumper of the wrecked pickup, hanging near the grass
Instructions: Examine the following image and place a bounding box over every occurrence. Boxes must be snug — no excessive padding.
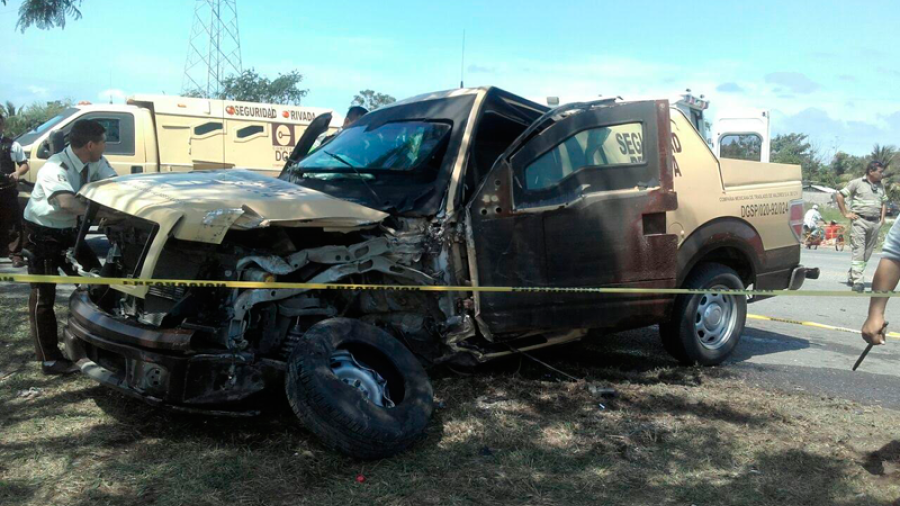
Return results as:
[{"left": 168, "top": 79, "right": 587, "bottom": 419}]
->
[{"left": 63, "top": 290, "right": 284, "bottom": 414}]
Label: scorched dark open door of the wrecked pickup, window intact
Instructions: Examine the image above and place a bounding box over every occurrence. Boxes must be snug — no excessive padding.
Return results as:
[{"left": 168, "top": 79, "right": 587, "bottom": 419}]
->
[{"left": 468, "top": 101, "right": 677, "bottom": 335}]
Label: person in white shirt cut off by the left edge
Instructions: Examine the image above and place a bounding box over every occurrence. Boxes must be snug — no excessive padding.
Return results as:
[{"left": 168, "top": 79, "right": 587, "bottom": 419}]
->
[{"left": 0, "top": 114, "right": 28, "bottom": 267}]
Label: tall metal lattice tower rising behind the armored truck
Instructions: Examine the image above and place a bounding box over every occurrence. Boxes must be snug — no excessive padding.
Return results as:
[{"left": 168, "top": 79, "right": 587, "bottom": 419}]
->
[{"left": 181, "top": 0, "right": 242, "bottom": 97}]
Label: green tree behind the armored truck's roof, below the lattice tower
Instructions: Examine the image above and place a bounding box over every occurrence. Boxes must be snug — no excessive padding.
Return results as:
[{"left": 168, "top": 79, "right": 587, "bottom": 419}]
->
[{"left": 184, "top": 68, "right": 309, "bottom": 105}]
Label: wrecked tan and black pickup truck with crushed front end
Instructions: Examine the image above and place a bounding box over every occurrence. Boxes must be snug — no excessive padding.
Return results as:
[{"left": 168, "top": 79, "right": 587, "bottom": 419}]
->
[{"left": 64, "top": 88, "right": 809, "bottom": 458}]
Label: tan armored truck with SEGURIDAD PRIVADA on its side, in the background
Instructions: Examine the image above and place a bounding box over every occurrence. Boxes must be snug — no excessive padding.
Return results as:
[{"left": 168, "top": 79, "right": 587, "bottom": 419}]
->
[{"left": 16, "top": 95, "right": 340, "bottom": 198}]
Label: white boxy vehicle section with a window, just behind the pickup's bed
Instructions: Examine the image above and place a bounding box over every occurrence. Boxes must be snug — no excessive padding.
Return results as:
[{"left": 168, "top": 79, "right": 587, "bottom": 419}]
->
[{"left": 713, "top": 109, "right": 771, "bottom": 163}]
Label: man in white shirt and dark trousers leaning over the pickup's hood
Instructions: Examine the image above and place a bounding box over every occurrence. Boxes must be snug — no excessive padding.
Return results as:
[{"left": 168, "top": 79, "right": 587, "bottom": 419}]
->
[{"left": 25, "top": 120, "right": 117, "bottom": 374}]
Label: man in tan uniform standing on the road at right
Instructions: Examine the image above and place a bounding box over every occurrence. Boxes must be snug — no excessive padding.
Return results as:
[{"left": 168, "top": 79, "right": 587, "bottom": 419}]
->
[{"left": 837, "top": 161, "right": 887, "bottom": 292}]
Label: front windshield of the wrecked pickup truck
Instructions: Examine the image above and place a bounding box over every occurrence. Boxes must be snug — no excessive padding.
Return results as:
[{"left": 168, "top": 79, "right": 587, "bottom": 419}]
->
[{"left": 290, "top": 121, "right": 450, "bottom": 179}]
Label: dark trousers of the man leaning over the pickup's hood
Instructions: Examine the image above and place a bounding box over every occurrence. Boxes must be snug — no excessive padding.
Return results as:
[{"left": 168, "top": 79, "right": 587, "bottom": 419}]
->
[{"left": 25, "top": 221, "right": 76, "bottom": 361}]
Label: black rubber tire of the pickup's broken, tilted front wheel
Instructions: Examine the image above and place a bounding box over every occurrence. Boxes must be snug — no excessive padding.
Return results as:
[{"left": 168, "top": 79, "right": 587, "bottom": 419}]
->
[{"left": 285, "top": 318, "right": 434, "bottom": 460}]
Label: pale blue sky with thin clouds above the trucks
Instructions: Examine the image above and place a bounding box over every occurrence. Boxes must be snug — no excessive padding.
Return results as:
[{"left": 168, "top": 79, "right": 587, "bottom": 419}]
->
[{"left": 0, "top": 0, "right": 900, "bottom": 156}]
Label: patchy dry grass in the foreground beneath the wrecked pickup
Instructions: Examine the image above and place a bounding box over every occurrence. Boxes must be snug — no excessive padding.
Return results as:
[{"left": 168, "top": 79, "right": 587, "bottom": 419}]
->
[{"left": 0, "top": 299, "right": 900, "bottom": 506}]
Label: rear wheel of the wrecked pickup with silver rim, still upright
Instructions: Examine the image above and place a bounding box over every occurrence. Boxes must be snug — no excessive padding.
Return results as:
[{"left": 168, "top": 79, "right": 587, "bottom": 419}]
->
[{"left": 659, "top": 264, "right": 747, "bottom": 365}]
